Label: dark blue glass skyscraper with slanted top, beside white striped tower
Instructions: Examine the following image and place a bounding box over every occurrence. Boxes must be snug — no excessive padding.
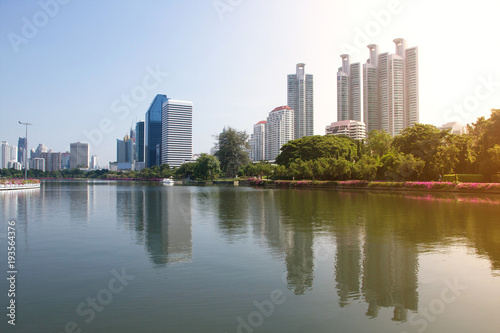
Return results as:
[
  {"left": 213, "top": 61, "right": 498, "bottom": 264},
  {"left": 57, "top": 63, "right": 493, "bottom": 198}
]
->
[{"left": 144, "top": 95, "right": 167, "bottom": 168}]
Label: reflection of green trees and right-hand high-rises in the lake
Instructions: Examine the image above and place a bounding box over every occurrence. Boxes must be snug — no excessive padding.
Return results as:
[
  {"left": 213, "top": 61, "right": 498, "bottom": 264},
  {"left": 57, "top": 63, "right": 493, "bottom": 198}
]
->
[{"left": 205, "top": 190, "right": 500, "bottom": 321}]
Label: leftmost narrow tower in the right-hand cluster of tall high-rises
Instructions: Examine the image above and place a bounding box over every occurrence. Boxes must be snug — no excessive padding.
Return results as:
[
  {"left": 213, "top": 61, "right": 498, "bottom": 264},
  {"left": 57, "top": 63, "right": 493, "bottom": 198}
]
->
[{"left": 337, "top": 54, "right": 361, "bottom": 121}]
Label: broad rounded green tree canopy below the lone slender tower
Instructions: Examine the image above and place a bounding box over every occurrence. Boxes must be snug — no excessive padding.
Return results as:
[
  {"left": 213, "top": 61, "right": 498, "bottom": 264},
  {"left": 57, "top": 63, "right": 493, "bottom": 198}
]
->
[{"left": 276, "top": 135, "right": 357, "bottom": 167}]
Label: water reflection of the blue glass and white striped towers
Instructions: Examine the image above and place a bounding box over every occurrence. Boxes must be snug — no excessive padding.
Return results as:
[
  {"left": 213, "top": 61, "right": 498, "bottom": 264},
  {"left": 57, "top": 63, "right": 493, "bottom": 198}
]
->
[{"left": 144, "top": 187, "right": 193, "bottom": 265}]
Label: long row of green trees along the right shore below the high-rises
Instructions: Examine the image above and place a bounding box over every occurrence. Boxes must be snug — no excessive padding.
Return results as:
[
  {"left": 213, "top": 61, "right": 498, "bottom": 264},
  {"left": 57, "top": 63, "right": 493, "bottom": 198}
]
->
[{"left": 240, "top": 110, "right": 500, "bottom": 181}]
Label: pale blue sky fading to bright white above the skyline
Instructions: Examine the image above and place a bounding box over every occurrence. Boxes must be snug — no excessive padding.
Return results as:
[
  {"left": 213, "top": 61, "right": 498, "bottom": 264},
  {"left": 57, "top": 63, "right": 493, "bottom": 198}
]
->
[{"left": 0, "top": 0, "right": 500, "bottom": 166}]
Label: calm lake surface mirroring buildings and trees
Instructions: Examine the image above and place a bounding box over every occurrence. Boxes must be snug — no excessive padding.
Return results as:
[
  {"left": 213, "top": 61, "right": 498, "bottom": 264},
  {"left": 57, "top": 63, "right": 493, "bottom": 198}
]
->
[{"left": 0, "top": 181, "right": 500, "bottom": 333}]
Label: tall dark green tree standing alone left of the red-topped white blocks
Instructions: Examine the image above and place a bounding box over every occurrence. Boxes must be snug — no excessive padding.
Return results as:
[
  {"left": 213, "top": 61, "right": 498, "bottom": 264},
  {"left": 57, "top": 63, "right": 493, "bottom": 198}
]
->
[{"left": 215, "top": 127, "right": 250, "bottom": 177}]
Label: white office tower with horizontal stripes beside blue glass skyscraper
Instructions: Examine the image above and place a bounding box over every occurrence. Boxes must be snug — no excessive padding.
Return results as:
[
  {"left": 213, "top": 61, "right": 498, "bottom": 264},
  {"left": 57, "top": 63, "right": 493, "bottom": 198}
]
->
[{"left": 161, "top": 98, "right": 193, "bottom": 167}]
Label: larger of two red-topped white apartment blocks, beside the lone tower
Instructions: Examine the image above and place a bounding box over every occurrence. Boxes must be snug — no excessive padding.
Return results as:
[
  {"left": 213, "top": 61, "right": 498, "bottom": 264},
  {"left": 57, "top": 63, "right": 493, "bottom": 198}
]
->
[{"left": 265, "top": 106, "right": 295, "bottom": 161}]
